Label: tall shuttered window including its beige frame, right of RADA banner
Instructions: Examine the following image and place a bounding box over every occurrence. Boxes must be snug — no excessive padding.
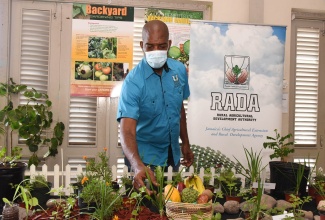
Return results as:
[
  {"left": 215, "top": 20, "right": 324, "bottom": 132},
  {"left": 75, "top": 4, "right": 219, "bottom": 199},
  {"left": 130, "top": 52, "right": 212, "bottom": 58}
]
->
[{"left": 290, "top": 11, "right": 325, "bottom": 166}]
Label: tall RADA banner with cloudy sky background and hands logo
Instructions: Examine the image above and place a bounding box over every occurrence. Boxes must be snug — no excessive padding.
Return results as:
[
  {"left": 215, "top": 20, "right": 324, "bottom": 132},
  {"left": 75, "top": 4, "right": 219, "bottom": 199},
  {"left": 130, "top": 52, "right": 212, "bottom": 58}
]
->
[{"left": 187, "top": 21, "right": 286, "bottom": 167}]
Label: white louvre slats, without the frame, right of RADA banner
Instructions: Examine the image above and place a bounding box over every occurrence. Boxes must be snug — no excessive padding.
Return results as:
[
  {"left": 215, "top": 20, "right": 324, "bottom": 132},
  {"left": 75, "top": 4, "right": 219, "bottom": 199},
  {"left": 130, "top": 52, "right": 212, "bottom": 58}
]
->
[{"left": 294, "top": 27, "right": 320, "bottom": 145}]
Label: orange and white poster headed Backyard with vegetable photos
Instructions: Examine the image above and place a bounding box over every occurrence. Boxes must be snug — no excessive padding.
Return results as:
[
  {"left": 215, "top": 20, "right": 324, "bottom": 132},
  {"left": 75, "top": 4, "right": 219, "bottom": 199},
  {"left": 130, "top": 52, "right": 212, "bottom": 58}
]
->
[{"left": 70, "top": 3, "right": 134, "bottom": 96}]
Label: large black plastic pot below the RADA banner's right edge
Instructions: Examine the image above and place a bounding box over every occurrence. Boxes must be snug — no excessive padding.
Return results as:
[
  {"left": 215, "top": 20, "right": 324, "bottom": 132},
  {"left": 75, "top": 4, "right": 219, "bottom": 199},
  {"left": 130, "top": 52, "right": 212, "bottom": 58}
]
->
[{"left": 269, "top": 161, "right": 310, "bottom": 199}]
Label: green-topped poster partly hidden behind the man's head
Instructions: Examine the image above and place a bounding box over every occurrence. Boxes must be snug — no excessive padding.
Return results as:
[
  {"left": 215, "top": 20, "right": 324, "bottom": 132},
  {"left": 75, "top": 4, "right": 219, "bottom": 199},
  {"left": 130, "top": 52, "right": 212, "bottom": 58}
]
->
[{"left": 145, "top": 8, "right": 203, "bottom": 67}]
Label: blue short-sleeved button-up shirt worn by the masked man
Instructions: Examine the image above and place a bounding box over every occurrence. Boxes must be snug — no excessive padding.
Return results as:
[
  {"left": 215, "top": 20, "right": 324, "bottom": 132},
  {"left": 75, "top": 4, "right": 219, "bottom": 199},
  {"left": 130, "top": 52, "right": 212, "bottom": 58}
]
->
[{"left": 117, "top": 58, "right": 190, "bottom": 166}]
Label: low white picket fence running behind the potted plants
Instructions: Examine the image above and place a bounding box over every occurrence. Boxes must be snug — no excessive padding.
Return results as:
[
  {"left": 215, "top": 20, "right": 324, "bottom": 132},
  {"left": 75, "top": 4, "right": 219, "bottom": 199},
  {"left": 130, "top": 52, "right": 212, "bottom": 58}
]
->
[{"left": 25, "top": 164, "right": 240, "bottom": 195}]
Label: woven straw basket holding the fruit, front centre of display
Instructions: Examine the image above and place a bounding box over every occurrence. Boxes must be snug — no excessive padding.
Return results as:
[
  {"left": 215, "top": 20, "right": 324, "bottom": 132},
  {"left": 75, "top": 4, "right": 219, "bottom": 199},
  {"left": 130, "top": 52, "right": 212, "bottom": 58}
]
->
[{"left": 166, "top": 201, "right": 213, "bottom": 220}]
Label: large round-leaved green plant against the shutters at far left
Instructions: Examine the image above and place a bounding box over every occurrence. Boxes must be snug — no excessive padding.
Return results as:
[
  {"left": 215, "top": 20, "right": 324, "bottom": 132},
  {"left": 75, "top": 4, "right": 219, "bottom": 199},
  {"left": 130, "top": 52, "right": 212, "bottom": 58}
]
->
[{"left": 0, "top": 79, "right": 65, "bottom": 166}]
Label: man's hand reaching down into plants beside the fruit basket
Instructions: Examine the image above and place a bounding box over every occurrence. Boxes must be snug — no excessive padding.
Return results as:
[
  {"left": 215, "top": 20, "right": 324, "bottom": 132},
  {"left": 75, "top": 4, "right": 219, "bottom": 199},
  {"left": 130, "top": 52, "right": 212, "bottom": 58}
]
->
[{"left": 133, "top": 165, "right": 159, "bottom": 195}]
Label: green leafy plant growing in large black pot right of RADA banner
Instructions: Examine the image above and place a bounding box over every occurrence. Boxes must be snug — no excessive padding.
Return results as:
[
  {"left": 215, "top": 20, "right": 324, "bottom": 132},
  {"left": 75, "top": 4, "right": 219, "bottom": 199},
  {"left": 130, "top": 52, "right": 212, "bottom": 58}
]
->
[{"left": 263, "top": 129, "right": 295, "bottom": 161}]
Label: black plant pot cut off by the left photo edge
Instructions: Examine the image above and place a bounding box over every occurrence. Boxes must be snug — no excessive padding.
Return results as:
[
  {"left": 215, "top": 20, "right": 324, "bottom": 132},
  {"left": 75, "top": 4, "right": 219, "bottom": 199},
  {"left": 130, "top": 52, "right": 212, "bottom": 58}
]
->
[{"left": 0, "top": 162, "right": 27, "bottom": 213}]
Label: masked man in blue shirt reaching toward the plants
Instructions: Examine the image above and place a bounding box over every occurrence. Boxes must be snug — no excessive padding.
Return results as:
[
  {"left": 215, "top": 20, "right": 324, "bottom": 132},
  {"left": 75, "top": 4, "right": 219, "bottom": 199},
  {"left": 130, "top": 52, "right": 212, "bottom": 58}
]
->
[{"left": 117, "top": 20, "right": 194, "bottom": 193}]
